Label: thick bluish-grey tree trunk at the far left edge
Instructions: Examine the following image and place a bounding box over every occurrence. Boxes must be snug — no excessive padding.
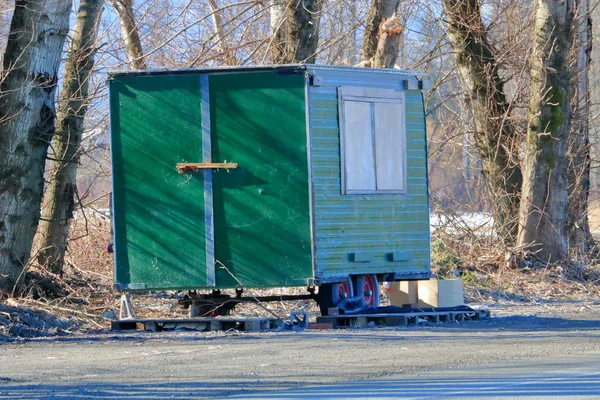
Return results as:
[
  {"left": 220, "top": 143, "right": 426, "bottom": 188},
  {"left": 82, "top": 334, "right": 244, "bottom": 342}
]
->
[{"left": 0, "top": 0, "right": 72, "bottom": 292}]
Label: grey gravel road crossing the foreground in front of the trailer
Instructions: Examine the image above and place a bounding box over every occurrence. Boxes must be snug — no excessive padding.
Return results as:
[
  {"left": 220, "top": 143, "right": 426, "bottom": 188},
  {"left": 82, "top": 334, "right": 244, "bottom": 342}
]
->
[{"left": 0, "top": 302, "right": 600, "bottom": 399}]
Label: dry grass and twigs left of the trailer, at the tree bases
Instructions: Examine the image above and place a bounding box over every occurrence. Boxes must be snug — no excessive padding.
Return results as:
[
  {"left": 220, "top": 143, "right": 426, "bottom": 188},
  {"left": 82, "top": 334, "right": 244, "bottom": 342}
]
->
[{"left": 0, "top": 218, "right": 119, "bottom": 337}]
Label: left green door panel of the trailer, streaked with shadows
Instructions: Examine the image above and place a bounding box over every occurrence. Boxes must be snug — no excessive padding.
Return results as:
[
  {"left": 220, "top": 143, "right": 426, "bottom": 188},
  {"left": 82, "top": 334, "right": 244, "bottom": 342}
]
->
[{"left": 110, "top": 75, "right": 214, "bottom": 291}]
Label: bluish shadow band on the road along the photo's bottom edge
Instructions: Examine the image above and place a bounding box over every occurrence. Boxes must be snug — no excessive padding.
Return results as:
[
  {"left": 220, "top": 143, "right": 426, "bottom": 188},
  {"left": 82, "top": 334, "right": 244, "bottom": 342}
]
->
[{"left": 0, "top": 373, "right": 600, "bottom": 399}]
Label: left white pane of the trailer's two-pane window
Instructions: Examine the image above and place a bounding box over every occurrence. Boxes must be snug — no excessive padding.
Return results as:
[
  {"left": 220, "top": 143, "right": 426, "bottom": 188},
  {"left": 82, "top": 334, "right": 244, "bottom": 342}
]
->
[{"left": 344, "top": 101, "right": 376, "bottom": 191}]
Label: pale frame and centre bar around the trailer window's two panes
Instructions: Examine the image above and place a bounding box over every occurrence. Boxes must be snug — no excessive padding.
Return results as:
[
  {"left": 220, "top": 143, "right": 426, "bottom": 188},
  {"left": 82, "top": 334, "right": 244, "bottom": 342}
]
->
[{"left": 338, "top": 86, "right": 408, "bottom": 195}]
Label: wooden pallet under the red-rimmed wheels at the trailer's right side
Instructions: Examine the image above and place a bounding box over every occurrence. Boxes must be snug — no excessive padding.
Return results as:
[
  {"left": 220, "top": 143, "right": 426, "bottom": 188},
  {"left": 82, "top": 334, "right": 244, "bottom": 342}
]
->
[{"left": 317, "top": 309, "right": 490, "bottom": 328}]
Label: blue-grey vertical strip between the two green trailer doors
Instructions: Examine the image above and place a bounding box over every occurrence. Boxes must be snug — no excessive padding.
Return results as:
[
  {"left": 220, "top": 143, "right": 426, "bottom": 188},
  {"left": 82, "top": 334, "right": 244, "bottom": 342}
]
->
[{"left": 200, "top": 74, "right": 216, "bottom": 286}]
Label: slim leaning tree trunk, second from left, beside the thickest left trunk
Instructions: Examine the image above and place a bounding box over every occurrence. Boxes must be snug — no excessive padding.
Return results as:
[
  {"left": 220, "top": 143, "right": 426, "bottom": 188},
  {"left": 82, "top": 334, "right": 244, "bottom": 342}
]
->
[{"left": 38, "top": 0, "right": 104, "bottom": 274}]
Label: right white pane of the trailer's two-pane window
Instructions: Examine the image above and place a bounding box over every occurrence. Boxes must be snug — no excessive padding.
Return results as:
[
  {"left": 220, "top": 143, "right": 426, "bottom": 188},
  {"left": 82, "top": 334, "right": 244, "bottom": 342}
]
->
[{"left": 375, "top": 103, "right": 404, "bottom": 190}]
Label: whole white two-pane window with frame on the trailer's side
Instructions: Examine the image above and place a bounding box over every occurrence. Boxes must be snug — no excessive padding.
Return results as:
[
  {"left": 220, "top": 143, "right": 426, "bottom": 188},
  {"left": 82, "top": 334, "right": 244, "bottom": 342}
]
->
[{"left": 338, "top": 87, "right": 406, "bottom": 194}]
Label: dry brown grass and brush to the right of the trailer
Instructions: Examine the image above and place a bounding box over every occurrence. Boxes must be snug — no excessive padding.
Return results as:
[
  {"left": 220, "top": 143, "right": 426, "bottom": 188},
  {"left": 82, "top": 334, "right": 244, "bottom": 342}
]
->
[{"left": 432, "top": 230, "right": 600, "bottom": 304}]
